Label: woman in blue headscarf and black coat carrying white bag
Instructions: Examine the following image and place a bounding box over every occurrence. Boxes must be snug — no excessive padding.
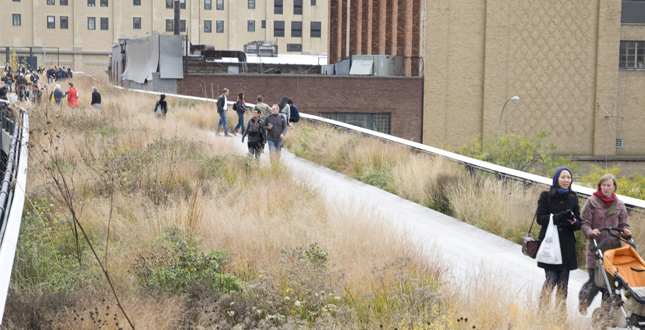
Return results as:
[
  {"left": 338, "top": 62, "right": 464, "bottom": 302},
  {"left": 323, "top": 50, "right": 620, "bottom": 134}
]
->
[{"left": 536, "top": 166, "right": 581, "bottom": 312}]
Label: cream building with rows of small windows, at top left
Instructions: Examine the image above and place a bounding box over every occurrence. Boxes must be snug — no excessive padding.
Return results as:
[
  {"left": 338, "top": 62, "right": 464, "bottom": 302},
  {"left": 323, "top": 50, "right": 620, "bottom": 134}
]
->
[{"left": 0, "top": 0, "right": 328, "bottom": 72}]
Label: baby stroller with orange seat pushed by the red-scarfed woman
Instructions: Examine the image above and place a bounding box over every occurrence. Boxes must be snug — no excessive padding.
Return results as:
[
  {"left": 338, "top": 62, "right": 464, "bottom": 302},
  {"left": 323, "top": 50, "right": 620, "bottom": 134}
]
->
[{"left": 592, "top": 227, "right": 645, "bottom": 329}]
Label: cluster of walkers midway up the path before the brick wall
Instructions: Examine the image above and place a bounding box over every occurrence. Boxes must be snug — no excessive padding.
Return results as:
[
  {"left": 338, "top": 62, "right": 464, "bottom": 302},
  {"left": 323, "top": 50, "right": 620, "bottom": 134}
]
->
[{"left": 216, "top": 88, "right": 300, "bottom": 160}]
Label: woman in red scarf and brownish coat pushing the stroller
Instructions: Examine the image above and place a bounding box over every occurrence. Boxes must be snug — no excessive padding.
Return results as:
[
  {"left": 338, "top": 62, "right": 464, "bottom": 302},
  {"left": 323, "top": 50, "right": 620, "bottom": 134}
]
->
[{"left": 578, "top": 174, "right": 632, "bottom": 315}]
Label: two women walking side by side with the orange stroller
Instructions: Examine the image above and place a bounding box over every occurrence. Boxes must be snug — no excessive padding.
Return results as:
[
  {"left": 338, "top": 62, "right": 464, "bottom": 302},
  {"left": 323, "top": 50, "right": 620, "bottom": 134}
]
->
[{"left": 536, "top": 167, "right": 631, "bottom": 315}]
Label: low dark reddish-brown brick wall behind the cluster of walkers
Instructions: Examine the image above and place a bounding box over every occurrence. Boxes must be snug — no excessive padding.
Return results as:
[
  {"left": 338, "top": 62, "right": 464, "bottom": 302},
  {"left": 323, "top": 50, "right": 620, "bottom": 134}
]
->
[{"left": 177, "top": 74, "right": 423, "bottom": 141}]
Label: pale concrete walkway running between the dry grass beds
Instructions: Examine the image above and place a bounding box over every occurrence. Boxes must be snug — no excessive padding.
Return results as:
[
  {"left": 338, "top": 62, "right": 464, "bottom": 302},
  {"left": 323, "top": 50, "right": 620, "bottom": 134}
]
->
[{"left": 228, "top": 138, "right": 600, "bottom": 318}]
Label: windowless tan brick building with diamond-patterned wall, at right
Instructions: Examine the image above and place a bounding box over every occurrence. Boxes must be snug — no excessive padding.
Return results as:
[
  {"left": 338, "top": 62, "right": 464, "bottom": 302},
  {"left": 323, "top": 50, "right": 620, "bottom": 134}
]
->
[{"left": 423, "top": 0, "right": 645, "bottom": 159}]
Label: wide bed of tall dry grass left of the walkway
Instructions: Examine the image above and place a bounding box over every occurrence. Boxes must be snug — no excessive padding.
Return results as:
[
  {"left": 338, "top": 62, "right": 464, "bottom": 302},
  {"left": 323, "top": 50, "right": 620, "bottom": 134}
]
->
[{"left": 4, "top": 75, "right": 443, "bottom": 329}]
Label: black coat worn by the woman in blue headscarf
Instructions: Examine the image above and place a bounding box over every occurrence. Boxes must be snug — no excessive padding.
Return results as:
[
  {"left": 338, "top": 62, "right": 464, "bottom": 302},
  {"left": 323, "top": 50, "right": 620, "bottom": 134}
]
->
[{"left": 536, "top": 191, "right": 581, "bottom": 271}]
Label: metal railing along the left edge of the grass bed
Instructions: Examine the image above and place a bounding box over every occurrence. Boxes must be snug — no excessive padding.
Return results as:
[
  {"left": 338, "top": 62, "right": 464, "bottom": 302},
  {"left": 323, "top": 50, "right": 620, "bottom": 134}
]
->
[{"left": 0, "top": 101, "right": 29, "bottom": 328}]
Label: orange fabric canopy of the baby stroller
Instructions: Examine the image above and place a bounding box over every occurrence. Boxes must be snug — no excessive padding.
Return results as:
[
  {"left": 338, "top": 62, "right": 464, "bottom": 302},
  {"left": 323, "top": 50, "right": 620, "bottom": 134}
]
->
[{"left": 603, "top": 244, "right": 645, "bottom": 288}]
